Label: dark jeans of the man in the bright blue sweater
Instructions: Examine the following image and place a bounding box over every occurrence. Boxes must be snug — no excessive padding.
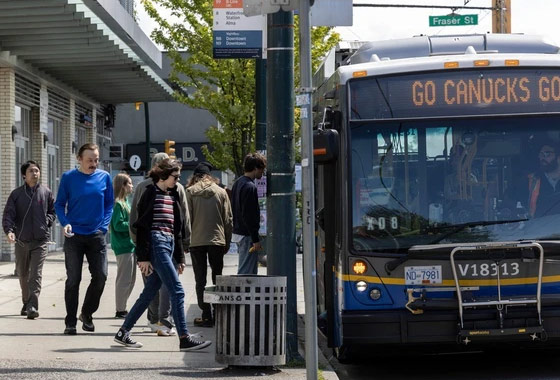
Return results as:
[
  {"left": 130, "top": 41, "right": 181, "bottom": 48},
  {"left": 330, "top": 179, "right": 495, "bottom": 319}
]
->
[{"left": 64, "top": 231, "right": 107, "bottom": 326}]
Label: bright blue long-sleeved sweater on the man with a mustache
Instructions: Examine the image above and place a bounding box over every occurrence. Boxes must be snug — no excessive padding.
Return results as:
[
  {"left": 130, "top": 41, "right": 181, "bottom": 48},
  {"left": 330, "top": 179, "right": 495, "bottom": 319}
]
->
[{"left": 54, "top": 169, "right": 114, "bottom": 235}]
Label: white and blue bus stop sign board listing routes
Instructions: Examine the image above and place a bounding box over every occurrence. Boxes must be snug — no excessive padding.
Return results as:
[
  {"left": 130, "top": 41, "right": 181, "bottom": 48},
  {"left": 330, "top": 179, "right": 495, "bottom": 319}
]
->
[{"left": 214, "top": 0, "right": 266, "bottom": 58}]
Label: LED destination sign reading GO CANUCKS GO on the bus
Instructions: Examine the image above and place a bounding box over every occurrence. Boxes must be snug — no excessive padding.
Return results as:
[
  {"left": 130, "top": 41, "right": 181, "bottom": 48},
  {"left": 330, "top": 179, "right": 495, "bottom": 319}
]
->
[{"left": 350, "top": 69, "right": 560, "bottom": 120}]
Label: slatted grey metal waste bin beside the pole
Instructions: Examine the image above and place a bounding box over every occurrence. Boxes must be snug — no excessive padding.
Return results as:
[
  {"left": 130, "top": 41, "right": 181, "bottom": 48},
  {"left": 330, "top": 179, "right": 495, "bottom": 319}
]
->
[{"left": 204, "top": 275, "right": 287, "bottom": 366}]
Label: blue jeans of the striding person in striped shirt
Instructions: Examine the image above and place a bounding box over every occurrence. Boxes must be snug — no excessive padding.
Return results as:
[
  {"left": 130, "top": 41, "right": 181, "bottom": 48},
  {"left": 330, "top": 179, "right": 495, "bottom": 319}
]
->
[{"left": 122, "top": 231, "right": 187, "bottom": 337}]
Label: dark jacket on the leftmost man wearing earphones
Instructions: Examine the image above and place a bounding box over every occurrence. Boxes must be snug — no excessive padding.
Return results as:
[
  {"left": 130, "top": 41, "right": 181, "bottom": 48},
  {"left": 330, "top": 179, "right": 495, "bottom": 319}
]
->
[{"left": 2, "top": 184, "right": 56, "bottom": 242}]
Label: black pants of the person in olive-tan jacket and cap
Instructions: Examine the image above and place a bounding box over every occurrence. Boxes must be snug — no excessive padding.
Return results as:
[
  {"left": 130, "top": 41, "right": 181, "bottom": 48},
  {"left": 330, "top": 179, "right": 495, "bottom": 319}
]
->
[{"left": 190, "top": 245, "right": 225, "bottom": 319}]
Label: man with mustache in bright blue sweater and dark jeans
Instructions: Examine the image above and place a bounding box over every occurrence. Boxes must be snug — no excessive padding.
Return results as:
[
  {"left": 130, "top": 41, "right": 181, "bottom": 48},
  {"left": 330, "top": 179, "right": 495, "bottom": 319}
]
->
[{"left": 54, "top": 144, "right": 113, "bottom": 335}]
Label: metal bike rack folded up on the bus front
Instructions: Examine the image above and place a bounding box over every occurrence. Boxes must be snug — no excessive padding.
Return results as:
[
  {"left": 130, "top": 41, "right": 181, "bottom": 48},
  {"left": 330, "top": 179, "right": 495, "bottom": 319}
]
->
[{"left": 450, "top": 242, "right": 544, "bottom": 344}]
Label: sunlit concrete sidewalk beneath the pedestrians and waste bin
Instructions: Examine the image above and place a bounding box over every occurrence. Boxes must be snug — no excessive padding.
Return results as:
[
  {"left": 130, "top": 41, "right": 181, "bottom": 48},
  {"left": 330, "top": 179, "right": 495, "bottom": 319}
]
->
[{"left": 0, "top": 251, "right": 337, "bottom": 380}]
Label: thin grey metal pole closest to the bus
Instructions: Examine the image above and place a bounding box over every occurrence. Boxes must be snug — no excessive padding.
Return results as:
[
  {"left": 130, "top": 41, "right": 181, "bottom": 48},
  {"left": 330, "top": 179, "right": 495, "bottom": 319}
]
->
[{"left": 299, "top": 0, "right": 317, "bottom": 380}]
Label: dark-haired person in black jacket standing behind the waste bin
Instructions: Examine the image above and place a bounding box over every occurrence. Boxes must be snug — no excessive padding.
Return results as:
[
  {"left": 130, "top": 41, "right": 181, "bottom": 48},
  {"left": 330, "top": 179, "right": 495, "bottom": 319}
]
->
[{"left": 231, "top": 153, "right": 266, "bottom": 274}]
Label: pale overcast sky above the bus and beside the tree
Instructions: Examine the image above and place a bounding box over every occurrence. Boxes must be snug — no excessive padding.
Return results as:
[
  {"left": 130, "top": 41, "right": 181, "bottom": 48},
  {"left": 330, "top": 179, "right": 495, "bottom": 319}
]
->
[{"left": 136, "top": 0, "right": 560, "bottom": 45}]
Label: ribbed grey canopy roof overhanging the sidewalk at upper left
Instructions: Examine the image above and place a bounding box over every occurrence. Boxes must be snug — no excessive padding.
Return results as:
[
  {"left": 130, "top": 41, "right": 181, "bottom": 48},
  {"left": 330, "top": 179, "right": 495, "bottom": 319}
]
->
[{"left": 0, "top": 0, "right": 173, "bottom": 104}]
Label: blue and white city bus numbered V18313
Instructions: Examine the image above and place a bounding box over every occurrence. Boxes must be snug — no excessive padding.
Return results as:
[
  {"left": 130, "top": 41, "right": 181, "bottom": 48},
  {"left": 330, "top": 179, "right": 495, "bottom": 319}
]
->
[{"left": 313, "top": 34, "right": 560, "bottom": 360}]
